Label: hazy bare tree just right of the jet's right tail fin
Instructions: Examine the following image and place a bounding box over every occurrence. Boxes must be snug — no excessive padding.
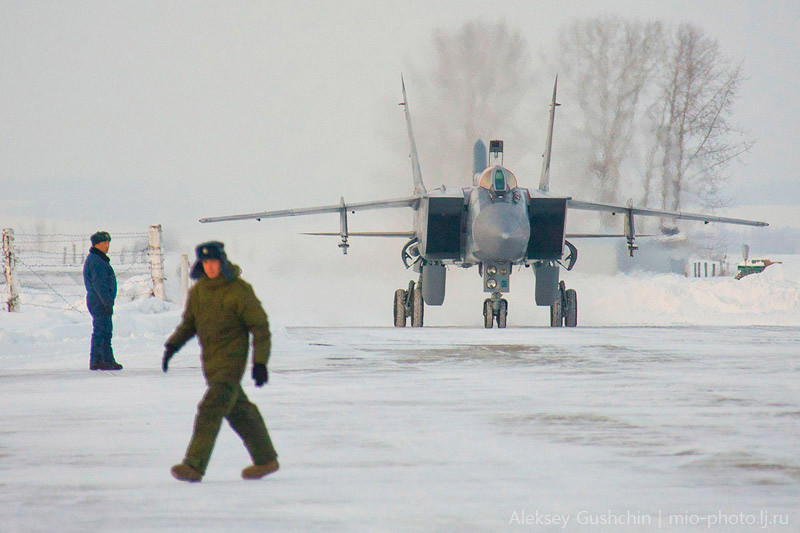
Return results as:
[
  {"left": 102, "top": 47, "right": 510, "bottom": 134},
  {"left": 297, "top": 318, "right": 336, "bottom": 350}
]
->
[{"left": 557, "top": 17, "right": 663, "bottom": 202}]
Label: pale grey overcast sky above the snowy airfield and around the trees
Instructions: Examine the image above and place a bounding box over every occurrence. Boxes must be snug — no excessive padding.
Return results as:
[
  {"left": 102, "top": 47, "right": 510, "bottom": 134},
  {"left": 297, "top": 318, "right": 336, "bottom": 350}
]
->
[{"left": 0, "top": 0, "right": 800, "bottom": 320}]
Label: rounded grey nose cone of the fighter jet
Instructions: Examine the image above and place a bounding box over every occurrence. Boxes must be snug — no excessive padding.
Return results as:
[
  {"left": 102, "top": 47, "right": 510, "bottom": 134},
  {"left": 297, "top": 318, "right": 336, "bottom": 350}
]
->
[{"left": 472, "top": 204, "right": 531, "bottom": 261}]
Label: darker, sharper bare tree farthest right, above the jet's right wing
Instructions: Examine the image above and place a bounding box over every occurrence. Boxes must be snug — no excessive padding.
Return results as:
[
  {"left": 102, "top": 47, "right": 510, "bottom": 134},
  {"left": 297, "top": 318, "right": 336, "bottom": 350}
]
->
[{"left": 644, "top": 24, "right": 753, "bottom": 211}]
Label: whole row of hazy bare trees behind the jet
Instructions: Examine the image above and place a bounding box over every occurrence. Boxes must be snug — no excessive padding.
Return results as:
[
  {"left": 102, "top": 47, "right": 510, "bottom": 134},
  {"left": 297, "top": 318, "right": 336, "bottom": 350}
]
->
[{"left": 410, "top": 17, "right": 753, "bottom": 229}]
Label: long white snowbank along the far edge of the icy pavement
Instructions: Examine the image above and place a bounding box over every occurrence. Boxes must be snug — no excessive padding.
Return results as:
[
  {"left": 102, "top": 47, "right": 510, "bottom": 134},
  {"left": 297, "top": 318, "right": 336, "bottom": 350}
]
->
[{"left": 0, "top": 255, "right": 800, "bottom": 334}]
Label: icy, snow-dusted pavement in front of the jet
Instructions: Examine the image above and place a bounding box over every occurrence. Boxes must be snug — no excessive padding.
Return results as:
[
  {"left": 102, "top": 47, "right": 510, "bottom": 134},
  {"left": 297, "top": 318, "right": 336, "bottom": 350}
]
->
[{"left": 0, "top": 324, "right": 800, "bottom": 532}]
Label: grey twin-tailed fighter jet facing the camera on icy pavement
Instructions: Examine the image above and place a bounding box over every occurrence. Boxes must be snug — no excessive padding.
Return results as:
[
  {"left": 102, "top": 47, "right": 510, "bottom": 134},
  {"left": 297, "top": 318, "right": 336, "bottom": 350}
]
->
[{"left": 200, "top": 77, "right": 768, "bottom": 328}]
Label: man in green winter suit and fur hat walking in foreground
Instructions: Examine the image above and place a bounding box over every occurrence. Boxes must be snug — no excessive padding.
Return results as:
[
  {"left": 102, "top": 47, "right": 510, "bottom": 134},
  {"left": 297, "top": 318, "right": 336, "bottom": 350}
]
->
[{"left": 163, "top": 241, "right": 278, "bottom": 481}]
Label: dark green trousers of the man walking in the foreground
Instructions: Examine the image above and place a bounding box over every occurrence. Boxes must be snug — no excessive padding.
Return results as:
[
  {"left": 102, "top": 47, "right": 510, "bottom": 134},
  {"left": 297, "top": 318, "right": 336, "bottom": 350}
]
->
[{"left": 183, "top": 383, "right": 278, "bottom": 474}]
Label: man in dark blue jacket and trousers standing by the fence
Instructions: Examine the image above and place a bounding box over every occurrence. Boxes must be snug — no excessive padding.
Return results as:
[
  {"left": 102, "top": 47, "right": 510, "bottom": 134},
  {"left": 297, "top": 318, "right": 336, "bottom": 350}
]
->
[{"left": 83, "top": 231, "right": 122, "bottom": 370}]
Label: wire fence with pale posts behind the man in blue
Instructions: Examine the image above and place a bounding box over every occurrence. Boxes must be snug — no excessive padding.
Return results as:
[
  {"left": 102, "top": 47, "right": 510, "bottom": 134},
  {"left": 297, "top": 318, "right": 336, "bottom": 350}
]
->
[{"left": 0, "top": 231, "right": 161, "bottom": 314}]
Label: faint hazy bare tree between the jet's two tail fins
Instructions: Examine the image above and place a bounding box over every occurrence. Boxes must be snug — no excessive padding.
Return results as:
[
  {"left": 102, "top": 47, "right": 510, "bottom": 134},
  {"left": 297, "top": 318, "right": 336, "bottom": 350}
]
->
[{"left": 412, "top": 21, "right": 533, "bottom": 185}]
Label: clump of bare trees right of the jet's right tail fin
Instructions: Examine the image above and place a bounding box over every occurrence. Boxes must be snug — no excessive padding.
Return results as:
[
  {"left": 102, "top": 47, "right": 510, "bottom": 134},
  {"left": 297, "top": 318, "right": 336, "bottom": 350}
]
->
[{"left": 554, "top": 17, "right": 753, "bottom": 222}]
